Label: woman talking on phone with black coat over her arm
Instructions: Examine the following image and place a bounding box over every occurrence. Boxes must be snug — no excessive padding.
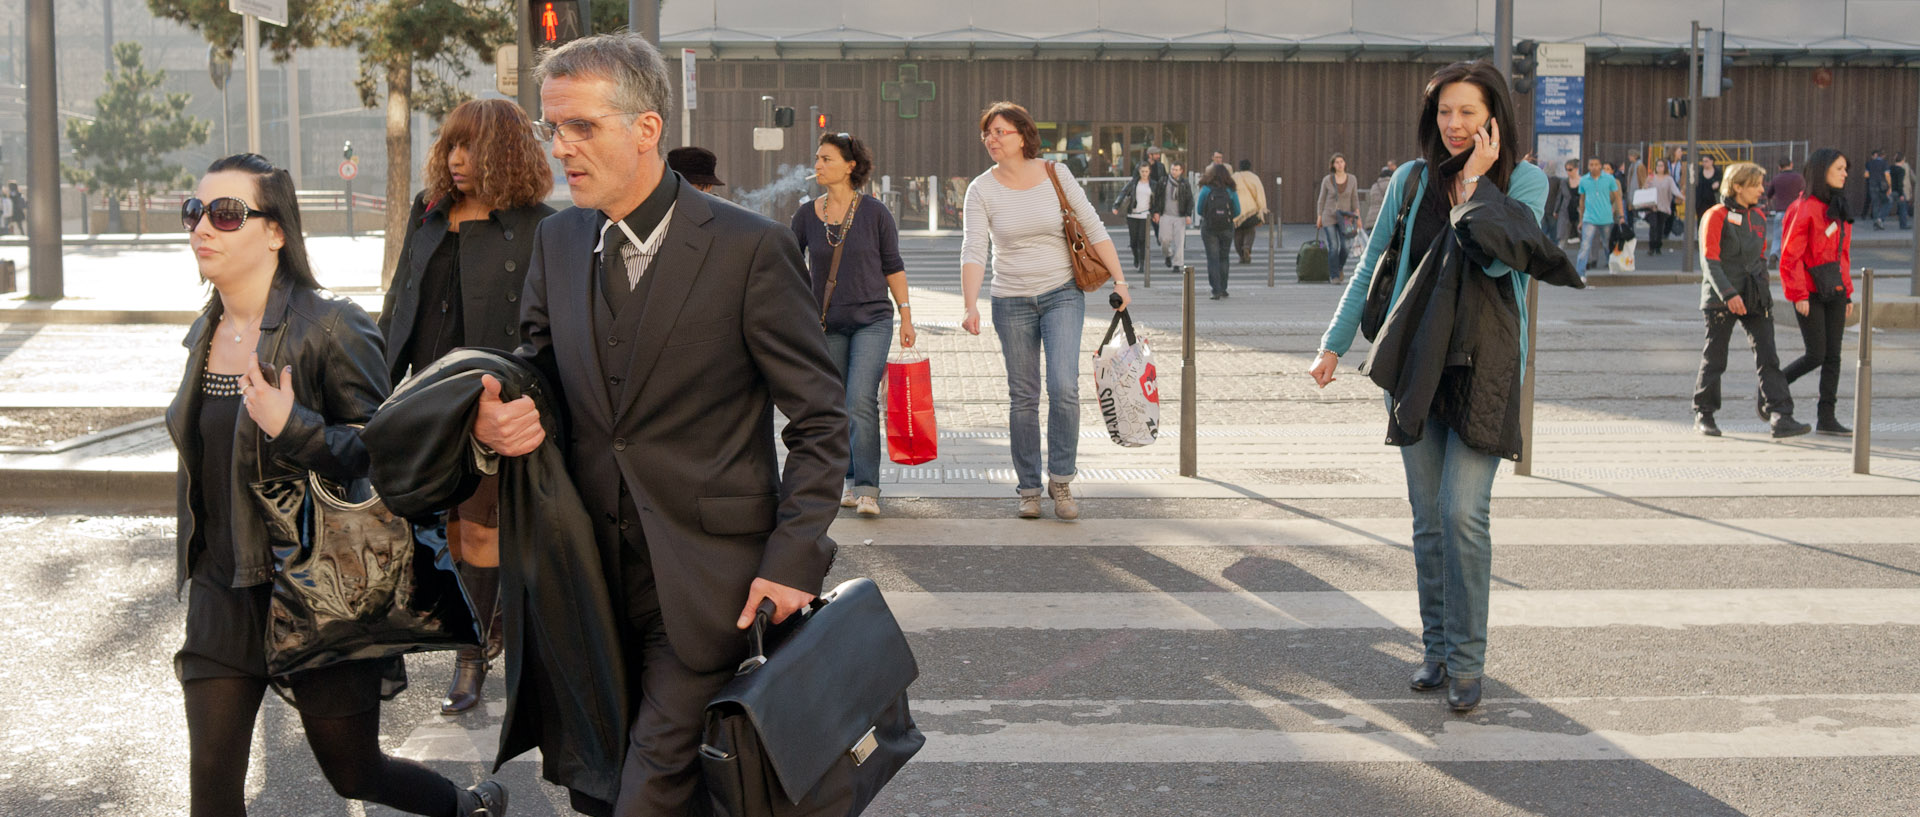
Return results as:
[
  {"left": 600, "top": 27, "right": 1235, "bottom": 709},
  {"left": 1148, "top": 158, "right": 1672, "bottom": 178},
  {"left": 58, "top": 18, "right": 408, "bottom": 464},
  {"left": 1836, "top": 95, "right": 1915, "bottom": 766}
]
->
[{"left": 1309, "top": 59, "right": 1582, "bottom": 712}]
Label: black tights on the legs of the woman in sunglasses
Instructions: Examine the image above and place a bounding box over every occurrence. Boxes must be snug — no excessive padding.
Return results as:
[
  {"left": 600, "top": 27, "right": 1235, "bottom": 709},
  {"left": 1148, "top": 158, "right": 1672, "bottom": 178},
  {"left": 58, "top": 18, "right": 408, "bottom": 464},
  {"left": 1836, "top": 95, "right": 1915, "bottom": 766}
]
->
[{"left": 182, "top": 677, "right": 459, "bottom": 817}]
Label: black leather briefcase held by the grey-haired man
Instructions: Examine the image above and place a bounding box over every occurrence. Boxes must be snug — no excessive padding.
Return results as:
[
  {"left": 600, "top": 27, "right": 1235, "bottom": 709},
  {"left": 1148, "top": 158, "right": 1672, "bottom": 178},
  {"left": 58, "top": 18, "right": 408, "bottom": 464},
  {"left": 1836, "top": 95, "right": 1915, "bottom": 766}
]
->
[{"left": 701, "top": 579, "right": 927, "bottom": 817}]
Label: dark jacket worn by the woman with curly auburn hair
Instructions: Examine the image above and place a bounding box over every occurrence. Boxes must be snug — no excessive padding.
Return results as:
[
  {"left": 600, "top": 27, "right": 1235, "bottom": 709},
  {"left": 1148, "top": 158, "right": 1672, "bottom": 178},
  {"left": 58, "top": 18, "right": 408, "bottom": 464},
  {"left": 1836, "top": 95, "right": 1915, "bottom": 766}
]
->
[{"left": 380, "top": 192, "right": 553, "bottom": 385}]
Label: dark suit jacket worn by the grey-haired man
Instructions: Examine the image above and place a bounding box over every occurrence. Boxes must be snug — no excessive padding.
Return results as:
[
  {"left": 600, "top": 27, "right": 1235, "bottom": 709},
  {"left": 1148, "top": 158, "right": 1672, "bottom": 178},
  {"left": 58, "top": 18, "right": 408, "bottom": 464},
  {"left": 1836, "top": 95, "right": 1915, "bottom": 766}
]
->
[{"left": 516, "top": 184, "right": 849, "bottom": 671}]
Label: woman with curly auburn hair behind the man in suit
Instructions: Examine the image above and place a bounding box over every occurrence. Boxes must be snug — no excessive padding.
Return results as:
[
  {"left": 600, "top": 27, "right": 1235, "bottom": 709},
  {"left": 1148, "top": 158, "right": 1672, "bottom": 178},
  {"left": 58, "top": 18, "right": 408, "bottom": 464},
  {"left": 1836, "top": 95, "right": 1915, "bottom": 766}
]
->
[{"left": 380, "top": 100, "right": 553, "bottom": 715}]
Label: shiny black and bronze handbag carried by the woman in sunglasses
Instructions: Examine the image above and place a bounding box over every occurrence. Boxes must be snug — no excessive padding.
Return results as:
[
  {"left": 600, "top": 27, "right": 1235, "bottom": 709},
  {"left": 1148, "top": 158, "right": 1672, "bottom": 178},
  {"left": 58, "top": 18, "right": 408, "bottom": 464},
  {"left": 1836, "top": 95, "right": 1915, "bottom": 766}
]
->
[{"left": 252, "top": 472, "right": 480, "bottom": 675}]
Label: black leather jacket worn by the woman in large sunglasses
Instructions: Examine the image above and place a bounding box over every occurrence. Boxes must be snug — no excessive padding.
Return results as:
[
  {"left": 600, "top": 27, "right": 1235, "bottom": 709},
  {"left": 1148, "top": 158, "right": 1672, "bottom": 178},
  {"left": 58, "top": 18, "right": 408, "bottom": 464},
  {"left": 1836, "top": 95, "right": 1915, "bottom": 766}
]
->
[{"left": 167, "top": 276, "right": 388, "bottom": 589}]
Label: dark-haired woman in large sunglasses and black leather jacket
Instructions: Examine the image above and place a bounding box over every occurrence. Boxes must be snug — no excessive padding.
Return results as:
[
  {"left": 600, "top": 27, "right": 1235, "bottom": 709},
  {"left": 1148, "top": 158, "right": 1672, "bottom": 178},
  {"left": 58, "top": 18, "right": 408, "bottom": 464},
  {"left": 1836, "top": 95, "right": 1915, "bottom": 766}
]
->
[{"left": 167, "top": 153, "right": 507, "bottom": 817}]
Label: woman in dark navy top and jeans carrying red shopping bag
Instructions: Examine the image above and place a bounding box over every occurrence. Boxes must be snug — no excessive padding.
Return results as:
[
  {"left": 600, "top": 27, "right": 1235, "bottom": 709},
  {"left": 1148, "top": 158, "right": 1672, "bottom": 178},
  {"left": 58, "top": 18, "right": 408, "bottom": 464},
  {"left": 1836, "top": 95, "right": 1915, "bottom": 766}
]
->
[{"left": 793, "top": 134, "right": 914, "bottom": 516}]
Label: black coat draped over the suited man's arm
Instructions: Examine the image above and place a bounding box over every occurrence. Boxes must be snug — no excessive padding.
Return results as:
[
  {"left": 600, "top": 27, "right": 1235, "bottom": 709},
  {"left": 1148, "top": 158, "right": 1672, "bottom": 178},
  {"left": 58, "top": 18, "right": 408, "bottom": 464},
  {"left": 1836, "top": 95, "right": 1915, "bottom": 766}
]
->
[{"left": 367, "top": 349, "right": 632, "bottom": 802}]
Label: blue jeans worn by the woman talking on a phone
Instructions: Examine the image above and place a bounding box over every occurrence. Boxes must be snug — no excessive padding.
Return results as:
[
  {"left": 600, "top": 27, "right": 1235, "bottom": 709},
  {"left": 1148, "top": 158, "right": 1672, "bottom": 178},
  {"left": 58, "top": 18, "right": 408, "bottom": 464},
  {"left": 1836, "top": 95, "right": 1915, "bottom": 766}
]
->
[{"left": 1400, "top": 412, "right": 1497, "bottom": 679}]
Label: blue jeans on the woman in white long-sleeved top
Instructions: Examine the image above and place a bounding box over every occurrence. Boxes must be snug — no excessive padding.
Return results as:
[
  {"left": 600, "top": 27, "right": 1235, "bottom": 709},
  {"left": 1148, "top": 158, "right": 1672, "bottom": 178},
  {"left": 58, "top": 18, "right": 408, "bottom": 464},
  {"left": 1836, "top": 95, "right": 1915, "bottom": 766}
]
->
[{"left": 993, "top": 280, "right": 1087, "bottom": 497}]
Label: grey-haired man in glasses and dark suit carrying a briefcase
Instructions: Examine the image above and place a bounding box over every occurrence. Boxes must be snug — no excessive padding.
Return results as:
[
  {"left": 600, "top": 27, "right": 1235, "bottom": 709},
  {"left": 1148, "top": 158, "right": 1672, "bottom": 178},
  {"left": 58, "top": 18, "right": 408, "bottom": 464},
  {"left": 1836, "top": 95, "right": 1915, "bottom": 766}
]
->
[{"left": 474, "top": 33, "right": 849, "bottom": 815}]
